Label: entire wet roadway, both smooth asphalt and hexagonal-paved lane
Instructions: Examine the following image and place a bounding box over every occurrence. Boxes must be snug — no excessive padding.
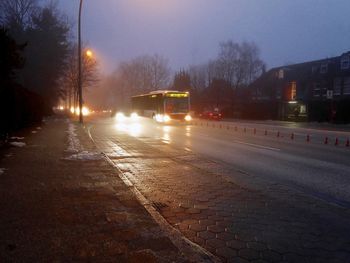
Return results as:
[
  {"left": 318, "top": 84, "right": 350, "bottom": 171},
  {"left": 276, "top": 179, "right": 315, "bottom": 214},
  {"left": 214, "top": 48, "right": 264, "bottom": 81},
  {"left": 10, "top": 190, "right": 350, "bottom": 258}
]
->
[{"left": 89, "top": 118, "right": 350, "bottom": 262}]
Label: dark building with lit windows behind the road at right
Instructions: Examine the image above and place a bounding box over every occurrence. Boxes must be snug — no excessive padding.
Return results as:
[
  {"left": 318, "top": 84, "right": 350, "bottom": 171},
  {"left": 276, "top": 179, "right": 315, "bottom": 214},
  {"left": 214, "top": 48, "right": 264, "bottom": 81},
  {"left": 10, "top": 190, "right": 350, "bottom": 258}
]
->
[{"left": 243, "top": 52, "right": 350, "bottom": 123}]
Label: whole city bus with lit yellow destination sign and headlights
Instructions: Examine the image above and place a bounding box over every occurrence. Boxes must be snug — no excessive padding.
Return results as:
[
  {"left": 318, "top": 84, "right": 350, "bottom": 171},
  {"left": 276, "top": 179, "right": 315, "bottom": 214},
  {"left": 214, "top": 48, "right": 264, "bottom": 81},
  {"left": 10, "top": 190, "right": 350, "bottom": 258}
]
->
[{"left": 131, "top": 90, "right": 192, "bottom": 122}]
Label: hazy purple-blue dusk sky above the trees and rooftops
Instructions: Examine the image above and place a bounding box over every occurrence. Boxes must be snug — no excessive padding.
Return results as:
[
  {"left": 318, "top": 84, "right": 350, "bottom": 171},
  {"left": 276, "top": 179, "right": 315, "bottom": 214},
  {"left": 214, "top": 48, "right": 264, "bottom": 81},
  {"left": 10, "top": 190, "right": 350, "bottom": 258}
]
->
[{"left": 59, "top": 0, "right": 350, "bottom": 72}]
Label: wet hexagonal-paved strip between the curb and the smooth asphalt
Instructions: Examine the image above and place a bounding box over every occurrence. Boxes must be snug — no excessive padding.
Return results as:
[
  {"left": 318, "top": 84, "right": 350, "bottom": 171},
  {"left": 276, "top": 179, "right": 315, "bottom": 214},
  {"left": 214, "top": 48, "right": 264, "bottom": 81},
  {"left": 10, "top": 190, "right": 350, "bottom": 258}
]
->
[{"left": 90, "top": 122, "right": 350, "bottom": 262}]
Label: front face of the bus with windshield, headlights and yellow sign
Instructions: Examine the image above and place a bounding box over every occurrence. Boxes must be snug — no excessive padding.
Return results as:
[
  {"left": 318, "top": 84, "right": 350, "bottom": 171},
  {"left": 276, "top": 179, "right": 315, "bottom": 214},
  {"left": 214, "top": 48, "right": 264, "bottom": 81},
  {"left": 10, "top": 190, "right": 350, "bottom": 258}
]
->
[{"left": 163, "top": 92, "right": 192, "bottom": 122}]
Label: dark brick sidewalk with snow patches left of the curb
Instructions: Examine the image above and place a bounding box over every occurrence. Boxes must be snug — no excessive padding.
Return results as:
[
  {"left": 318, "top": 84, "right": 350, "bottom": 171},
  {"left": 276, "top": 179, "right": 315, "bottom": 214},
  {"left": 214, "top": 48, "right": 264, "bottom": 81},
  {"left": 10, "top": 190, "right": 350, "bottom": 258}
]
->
[{"left": 0, "top": 118, "right": 208, "bottom": 262}]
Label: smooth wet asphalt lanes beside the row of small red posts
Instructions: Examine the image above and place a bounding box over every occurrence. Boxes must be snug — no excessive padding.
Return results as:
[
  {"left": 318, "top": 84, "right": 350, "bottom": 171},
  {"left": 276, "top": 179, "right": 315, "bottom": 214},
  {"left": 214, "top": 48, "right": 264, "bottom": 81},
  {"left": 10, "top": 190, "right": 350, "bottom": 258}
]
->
[{"left": 91, "top": 118, "right": 350, "bottom": 208}]
